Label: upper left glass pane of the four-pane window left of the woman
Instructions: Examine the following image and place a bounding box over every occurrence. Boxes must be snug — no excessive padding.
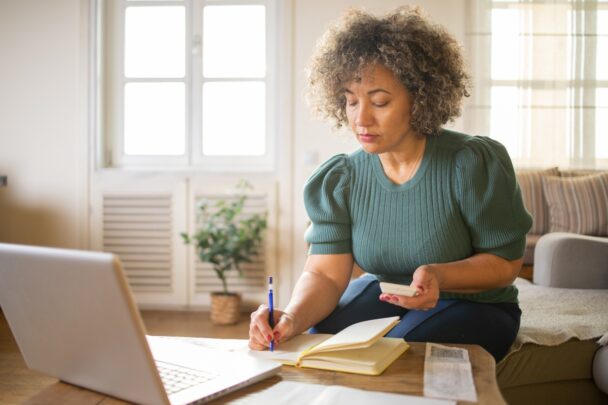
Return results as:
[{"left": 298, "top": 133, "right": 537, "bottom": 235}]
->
[{"left": 125, "top": 6, "right": 186, "bottom": 77}]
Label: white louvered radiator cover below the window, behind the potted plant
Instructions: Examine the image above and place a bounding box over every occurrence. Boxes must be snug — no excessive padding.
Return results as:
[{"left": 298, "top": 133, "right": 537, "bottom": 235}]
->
[{"left": 91, "top": 177, "right": 276, "bottom": 308}]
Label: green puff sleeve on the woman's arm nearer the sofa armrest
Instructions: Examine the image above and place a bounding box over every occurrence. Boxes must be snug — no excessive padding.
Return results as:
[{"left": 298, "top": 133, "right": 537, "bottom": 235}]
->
[{"left": 455, "top": 136, "right": 532, "bottom": 260}]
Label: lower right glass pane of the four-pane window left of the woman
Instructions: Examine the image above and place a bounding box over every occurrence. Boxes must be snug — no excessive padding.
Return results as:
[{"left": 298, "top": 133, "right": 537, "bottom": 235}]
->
[{"left": 203, "top": 82, "right": 266, "bottom": 156}]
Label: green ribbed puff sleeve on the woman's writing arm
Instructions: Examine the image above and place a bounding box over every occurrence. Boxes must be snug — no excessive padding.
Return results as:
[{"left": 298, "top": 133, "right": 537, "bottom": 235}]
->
[{"left": 304, "top": 155, "right": 352, "bottom": 254}]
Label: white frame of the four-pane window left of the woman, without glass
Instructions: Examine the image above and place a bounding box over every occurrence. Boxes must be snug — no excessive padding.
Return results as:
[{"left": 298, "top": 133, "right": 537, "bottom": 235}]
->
[{"left": 96, "top": 0, "right": 279, "bottom": 172}]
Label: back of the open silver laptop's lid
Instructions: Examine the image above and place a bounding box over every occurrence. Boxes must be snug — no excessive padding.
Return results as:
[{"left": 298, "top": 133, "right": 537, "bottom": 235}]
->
[{"left": 0, "top": 244, "right": 169, "bottom": 404}]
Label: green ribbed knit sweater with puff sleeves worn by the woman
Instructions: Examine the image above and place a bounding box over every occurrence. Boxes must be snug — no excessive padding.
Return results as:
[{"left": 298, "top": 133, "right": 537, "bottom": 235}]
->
[{"left": 304, "top": 130, "right": 532, "bottom": 302}]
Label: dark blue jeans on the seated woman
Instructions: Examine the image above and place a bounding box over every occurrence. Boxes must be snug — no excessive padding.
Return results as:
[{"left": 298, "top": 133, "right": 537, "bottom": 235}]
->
[{"left": 310, "top": 276, "right": 521, "bottom": 362}]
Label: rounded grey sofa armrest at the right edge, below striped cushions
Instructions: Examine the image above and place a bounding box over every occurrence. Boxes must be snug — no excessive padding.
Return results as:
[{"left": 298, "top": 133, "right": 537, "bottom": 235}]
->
[{"left": 533, "top": 232, "right": 608, "bottom": 289}]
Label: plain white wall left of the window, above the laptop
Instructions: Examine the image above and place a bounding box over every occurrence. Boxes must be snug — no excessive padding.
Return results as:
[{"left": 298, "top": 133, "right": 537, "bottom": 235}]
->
[{"left": 0, "top": 0, "right": 87, "bottom": 247}]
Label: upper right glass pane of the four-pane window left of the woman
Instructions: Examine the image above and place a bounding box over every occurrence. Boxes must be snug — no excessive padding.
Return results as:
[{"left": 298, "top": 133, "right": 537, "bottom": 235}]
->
[{"left": 203, "top": 5, "right": 266, "bottom": 77}]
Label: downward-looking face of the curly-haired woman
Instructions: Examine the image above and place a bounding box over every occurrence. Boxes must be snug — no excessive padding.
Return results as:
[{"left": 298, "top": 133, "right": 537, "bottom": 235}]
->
[{"left": 344, "top": 64, "right": 415, "bottom": 153}]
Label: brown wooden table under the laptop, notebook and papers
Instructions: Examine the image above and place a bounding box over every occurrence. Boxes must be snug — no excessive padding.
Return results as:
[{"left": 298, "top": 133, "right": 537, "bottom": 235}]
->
[{"left": 25, "top": 343, "right": 506, "bottom": 405}]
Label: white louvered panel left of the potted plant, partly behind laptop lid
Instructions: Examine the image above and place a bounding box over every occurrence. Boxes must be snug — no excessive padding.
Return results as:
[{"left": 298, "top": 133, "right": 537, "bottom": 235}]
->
[{"left": 91, "top": 175, "right": 188, "bottom": 308}]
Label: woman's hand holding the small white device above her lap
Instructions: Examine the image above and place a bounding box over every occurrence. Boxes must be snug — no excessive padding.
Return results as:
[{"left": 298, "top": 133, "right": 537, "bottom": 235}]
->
[{"left": 380, "top": 265, "right": 439, "bottom": 311}]
